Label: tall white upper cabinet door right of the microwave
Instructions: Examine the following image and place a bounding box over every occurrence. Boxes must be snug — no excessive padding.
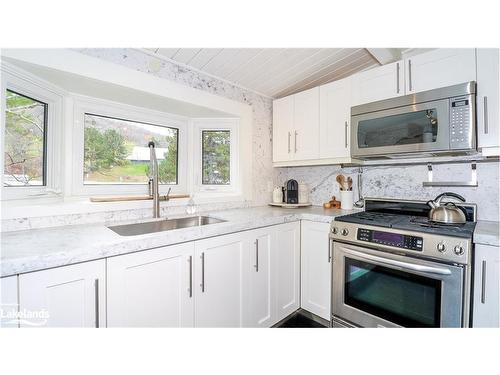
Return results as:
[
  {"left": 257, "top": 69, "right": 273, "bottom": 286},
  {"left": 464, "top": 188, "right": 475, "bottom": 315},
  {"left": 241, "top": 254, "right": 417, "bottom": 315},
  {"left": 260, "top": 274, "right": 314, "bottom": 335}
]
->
[{"left": 477, "top": 48, "right": 500, "bottom": 155}]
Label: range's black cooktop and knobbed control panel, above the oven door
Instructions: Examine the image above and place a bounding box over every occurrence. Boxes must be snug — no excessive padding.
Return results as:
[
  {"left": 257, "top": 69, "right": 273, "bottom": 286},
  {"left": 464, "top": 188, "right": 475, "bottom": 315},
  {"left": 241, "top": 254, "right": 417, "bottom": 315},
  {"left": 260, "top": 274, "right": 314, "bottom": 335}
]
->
[{"left": 330, "top": 198, "right": 476, "bottom": 264}]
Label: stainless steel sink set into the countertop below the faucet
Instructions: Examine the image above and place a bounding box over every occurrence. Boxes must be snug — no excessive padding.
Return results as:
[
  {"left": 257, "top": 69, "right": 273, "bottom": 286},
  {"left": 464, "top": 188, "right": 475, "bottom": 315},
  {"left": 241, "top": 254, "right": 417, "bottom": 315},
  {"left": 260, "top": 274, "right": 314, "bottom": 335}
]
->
[{"left": 108, "top": 216, "right": 226, "bottom": 236}]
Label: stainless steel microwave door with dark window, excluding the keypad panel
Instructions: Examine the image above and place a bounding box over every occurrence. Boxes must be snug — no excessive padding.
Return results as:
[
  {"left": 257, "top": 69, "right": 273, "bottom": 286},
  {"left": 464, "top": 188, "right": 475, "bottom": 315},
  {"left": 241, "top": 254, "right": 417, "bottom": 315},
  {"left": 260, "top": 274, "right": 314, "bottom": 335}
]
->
[{"left": 351, "top": 99, "right": 450, "bottom": 159}]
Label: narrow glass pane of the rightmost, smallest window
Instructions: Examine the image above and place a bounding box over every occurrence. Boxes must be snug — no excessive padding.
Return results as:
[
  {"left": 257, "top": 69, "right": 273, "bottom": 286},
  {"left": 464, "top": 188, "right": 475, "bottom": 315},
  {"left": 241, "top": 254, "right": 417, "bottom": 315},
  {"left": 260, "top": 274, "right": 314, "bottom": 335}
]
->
[{"left": 202, "top": 130, "right": 231, "bottom": 185}]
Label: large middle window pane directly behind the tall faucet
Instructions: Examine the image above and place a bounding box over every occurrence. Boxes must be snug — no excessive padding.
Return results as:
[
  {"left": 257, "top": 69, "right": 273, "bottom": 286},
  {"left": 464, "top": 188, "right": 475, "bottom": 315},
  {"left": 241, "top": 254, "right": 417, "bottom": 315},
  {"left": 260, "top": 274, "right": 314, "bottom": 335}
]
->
[{"left": 83, "top": 113, "right": 179, "bottom": 184}]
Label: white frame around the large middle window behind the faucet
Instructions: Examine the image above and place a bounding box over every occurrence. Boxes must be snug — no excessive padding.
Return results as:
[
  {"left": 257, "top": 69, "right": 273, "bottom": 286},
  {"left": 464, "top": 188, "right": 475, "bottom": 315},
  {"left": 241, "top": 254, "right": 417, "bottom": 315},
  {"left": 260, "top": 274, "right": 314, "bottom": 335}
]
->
[{"left": 71, "top": 94, "right": 188, "bottom": 196}]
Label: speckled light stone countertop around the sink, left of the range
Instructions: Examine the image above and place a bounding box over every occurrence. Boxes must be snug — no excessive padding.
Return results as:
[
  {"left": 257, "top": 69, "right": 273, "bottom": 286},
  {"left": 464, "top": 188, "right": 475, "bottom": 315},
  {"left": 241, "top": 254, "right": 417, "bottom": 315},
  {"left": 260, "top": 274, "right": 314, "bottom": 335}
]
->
[{"left": 0, "top": 206, "right": 355, "bottom": 277}]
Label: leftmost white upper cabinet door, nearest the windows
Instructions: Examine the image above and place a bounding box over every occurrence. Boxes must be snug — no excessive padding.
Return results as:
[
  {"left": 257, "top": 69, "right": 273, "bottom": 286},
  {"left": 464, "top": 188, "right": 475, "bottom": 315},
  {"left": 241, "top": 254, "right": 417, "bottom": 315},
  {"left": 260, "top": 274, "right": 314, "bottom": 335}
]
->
[{"left": 273, "top": 95, "right": 294, "bottom": 162}]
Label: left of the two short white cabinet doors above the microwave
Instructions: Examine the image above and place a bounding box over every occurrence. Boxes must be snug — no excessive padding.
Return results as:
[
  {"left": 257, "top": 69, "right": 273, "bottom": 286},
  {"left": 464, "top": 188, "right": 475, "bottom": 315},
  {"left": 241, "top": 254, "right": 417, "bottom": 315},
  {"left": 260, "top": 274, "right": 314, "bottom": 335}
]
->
[{"left": 352, "top": 61, "right": 405, "bottom": 106}]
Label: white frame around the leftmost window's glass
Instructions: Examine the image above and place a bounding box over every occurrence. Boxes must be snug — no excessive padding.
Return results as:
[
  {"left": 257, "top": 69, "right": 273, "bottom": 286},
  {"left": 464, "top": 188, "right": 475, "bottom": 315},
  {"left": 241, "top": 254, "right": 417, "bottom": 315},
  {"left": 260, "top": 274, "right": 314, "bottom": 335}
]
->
[{"left": 0, "top": 62, "right": 65, "bottom": 200}]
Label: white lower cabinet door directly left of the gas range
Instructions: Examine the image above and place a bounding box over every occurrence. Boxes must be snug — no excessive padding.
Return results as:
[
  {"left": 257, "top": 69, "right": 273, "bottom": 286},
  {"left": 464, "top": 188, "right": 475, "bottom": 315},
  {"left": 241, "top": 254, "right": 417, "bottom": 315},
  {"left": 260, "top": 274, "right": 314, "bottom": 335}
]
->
[{"left": 300, "top": 220, "right": 331, "bottom": 320}]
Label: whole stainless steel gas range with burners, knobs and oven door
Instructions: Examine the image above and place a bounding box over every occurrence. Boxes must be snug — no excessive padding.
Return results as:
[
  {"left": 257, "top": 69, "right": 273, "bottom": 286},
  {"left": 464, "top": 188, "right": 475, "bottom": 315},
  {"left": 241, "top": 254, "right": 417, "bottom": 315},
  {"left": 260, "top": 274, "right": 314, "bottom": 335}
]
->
[{"left": 329, "top": 198, "right": 476, "bottom": 327}]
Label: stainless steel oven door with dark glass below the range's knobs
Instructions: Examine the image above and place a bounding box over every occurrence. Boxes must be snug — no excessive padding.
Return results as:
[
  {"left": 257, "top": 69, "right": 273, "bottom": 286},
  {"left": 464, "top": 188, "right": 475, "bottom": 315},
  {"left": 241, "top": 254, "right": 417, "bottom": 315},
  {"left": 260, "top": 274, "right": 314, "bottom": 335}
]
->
[{"left": 332, "top": 242, "right": 464, "bottom": 327}]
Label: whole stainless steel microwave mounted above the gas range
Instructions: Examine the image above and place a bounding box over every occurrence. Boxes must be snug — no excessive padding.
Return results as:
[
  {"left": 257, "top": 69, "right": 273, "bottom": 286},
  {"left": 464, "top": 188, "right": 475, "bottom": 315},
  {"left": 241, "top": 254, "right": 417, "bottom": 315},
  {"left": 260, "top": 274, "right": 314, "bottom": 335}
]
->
[{"left": 351, "top": 82, "right": 476, "bottom": 159}]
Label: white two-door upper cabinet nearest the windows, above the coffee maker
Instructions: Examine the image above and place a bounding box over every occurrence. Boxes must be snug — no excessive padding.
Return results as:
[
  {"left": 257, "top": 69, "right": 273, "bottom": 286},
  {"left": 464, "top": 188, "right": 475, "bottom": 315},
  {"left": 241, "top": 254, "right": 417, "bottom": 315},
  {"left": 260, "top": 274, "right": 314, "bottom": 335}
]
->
[{"left": 273, "top": 87, "right": 319, "bottom": 162}]
